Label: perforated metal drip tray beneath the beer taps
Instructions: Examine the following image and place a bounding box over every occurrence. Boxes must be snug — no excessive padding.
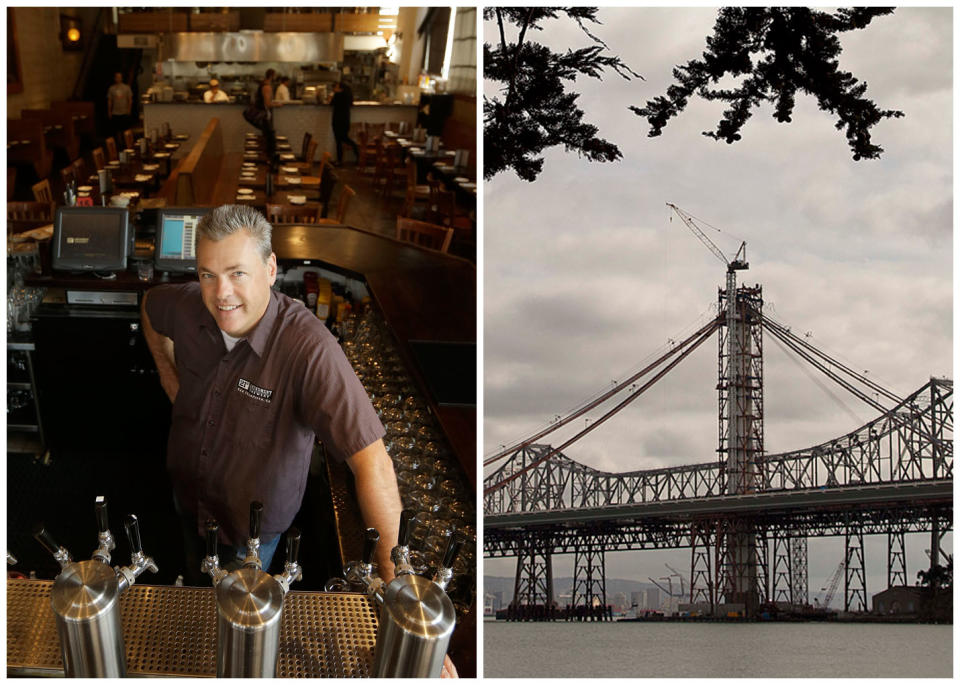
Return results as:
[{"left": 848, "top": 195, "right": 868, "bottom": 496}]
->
[{"left": 7, "top": 580, "right": 377, "bottom": 678}]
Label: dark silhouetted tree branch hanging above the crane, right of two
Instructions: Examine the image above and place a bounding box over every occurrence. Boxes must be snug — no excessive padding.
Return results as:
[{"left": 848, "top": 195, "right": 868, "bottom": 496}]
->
[{"left": 630, "top": 7, "right": 903, "bottom": 160}]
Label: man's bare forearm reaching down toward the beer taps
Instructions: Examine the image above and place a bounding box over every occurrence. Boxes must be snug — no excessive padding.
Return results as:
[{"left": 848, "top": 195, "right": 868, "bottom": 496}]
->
[{"left": 347, "top": 440, "right": 402, "bottom": 583}]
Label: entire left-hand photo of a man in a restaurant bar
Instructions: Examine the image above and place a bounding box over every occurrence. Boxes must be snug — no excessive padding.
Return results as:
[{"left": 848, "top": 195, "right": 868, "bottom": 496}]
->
[{"left": 6, "top": 6, "right": 478, "bottom": 677}]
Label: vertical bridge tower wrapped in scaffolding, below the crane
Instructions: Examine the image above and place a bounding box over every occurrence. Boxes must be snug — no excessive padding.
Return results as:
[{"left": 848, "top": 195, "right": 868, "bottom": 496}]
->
[{"left": 717, "top": 280, "right": 763, "bottom": 615}]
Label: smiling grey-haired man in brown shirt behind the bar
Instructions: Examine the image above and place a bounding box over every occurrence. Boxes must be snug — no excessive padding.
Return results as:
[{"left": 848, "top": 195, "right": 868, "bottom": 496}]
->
[{"left": 142, "top": 205, "right": 401, "bottom": 583}]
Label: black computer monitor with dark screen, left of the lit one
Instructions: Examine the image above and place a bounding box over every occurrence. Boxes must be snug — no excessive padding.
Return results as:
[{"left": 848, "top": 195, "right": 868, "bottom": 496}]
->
[{"left": 52, "top": 207, "right": 130, "bottom": 271}]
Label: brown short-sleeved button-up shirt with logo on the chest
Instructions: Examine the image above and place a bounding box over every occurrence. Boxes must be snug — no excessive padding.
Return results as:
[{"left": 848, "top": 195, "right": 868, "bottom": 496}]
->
[{"left": 146, "top": 282, "right": 384, "bottom": 545}]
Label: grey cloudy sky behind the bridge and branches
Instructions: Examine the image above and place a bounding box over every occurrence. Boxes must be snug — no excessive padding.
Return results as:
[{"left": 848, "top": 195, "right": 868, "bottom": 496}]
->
[{"left": 484, "top": 8, "right": 953, "bottom": 593}]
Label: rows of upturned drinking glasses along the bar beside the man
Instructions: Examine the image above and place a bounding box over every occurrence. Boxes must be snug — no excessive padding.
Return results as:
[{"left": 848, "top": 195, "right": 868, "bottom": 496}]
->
[{"left": 343, "top": 307, "right": 477, "bottom": 618}]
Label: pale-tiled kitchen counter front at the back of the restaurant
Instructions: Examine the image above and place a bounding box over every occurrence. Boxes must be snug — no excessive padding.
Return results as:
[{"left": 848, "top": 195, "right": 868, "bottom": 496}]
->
[{"left": 143, "top": 102, "right": 417, "bottom": 159}]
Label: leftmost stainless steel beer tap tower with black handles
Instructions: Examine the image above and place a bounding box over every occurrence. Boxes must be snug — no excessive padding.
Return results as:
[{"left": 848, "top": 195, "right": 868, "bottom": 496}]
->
[{"left": 33, "top": 497, "right": 157, "bottom": 678}]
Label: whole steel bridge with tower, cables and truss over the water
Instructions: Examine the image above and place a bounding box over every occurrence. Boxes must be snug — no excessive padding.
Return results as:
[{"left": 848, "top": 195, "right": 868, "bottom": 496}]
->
[{"left": 483, "top": 272, "right": 953, "bottom": 618}]
